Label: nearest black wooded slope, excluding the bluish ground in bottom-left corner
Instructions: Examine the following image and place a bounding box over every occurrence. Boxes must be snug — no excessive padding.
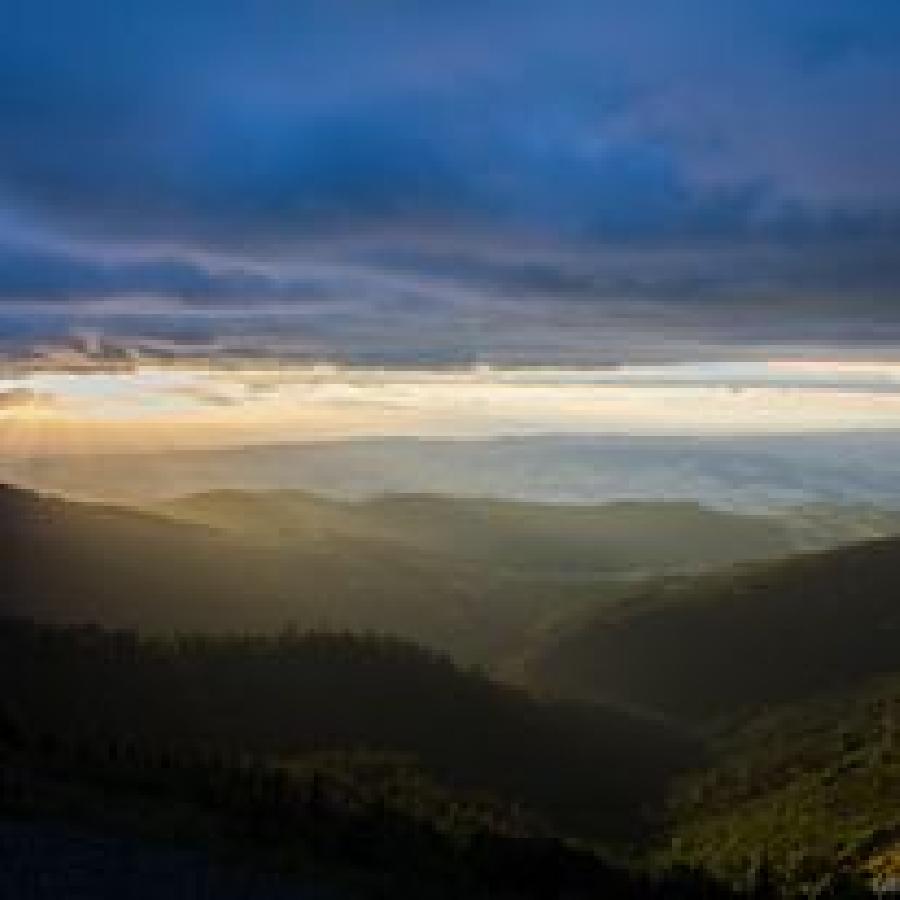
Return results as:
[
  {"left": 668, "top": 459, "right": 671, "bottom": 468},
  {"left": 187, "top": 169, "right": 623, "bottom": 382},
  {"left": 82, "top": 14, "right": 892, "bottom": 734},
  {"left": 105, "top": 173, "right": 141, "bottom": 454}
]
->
[{"left": 0, "top": 714, "right": 744, "bottom": 900}]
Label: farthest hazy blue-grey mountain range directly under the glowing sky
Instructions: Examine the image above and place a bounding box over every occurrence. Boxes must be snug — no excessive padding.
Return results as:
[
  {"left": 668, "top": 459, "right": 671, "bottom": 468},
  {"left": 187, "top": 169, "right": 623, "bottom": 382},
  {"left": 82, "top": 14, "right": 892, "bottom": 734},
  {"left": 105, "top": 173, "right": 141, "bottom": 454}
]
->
[{"left": 10, "top": 431, "right": 900, "bottom": 512}]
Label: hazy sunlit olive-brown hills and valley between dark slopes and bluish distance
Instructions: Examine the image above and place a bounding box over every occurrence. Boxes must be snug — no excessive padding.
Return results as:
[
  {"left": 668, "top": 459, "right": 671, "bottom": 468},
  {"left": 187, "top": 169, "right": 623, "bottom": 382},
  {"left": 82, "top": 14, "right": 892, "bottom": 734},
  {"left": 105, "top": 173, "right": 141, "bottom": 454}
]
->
[{"left": 0, "top": 488, "right": 900, "bottom": 664}]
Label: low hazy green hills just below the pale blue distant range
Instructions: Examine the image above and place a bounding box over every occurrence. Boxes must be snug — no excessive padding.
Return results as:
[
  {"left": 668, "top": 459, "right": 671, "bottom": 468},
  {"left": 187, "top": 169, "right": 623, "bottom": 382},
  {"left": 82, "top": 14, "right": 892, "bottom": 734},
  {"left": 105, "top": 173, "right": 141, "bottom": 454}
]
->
[{"left": 153, "top": 491, "right": 856, "bottom": 577}]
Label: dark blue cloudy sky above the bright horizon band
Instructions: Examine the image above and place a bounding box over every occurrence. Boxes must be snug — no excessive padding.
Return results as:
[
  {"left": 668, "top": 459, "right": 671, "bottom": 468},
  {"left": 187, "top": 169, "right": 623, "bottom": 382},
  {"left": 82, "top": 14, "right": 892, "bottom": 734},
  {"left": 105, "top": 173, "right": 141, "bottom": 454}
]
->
[{"left": 0, "top": 0, "right": 900, "bottom": 364}]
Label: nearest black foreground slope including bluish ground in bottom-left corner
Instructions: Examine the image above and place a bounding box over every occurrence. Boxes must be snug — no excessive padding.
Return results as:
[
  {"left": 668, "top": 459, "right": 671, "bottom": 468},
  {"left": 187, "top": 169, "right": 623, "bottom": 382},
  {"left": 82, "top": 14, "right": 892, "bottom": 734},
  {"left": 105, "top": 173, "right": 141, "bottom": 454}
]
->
[{"left": 0, "top": 737, "right": 736, "bottom": 900}]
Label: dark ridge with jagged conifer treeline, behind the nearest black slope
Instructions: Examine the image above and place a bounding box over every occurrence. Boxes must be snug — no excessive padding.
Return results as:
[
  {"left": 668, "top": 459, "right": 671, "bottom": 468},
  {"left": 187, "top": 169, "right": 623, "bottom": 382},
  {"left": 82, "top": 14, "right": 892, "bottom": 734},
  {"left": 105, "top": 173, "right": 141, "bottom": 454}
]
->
[{"left": 0, "top": 621, "right": 697, "bottom": 835}]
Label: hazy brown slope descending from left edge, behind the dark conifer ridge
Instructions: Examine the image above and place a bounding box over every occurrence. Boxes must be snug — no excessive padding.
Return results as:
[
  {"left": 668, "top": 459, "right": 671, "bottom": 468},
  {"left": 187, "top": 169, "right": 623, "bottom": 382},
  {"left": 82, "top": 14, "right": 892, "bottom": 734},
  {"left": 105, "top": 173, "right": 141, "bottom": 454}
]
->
[{"left": 0, "top": 488, "right": 577, "bottom": 659}]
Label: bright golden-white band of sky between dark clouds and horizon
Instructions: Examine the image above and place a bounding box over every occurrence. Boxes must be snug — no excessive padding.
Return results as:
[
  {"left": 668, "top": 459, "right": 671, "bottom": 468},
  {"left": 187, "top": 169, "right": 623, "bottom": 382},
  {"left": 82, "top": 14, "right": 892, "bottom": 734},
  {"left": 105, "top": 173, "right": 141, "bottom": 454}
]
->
[{"left": 0, "top": 360, "right": 900, "bottom": 458}]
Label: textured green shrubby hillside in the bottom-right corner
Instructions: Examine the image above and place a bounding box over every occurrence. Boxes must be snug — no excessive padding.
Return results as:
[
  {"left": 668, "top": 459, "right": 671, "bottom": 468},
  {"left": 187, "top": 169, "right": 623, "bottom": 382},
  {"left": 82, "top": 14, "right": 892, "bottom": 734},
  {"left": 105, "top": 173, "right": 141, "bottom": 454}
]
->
[{"left": 657, "top": 675, "right": 900, "bottom": 889}]
